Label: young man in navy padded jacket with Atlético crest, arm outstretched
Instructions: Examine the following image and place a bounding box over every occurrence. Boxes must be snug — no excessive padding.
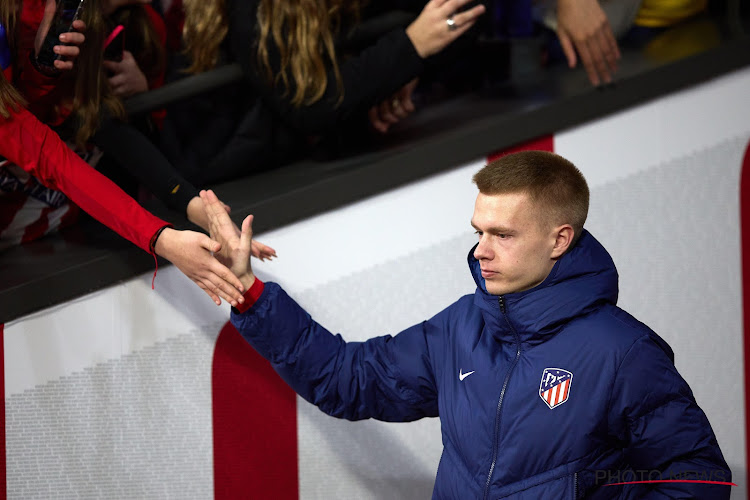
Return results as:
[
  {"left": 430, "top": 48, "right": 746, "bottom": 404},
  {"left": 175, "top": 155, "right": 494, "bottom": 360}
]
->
[{"left": 201, "top": 151, "right": 731, "bottom": 500}]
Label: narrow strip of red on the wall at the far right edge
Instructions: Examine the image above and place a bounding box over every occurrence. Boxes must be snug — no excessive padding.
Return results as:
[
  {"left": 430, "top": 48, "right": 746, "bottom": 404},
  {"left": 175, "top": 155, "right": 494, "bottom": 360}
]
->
[{"left": 740, "top": 142, "right": 750, "bottom": 482}]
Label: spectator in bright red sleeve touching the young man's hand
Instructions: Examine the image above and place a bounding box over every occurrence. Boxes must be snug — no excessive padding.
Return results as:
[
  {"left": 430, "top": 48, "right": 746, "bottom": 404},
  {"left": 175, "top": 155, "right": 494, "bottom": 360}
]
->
[{"left": 0, "top": 2, "right": 273, "bottom": 304}]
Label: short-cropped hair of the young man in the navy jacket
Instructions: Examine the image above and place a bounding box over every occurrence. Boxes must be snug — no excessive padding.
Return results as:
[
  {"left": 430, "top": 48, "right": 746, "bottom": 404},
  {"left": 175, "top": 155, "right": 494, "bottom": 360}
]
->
[{"left": 473, "top": 151, "right": 589, "bottom": 241}]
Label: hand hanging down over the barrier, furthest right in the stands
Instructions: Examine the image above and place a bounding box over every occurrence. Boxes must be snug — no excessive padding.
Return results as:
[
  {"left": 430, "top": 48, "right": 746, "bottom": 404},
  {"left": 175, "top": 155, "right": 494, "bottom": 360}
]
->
[{"left": 557, "top": 0, "right": 620, "bottom": 85}]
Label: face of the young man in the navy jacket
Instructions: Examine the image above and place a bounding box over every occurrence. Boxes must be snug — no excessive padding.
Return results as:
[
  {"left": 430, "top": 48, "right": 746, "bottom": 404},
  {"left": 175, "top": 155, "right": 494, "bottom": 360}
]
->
[{"left": 471, "top": 193, "right": 557, "bottom": 295}]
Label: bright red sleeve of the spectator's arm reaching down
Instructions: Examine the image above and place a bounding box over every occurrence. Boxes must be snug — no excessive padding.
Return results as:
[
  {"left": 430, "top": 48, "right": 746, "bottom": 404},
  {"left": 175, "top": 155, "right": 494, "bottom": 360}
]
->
[{"left": 0, "top": 110, "right": 168, "bottom": 253}]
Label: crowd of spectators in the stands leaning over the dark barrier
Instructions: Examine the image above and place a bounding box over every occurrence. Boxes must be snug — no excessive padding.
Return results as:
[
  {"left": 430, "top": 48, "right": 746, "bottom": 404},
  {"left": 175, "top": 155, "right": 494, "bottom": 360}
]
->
[{"left": 0, "top": 0, "right": 707, "bottom": 301}]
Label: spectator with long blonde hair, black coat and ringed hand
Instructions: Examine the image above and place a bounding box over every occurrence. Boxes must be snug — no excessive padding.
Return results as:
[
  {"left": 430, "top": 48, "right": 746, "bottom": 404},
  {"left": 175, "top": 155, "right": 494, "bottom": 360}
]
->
[{"left": 163, "top": 0, "right": 485, "bottom": 183}]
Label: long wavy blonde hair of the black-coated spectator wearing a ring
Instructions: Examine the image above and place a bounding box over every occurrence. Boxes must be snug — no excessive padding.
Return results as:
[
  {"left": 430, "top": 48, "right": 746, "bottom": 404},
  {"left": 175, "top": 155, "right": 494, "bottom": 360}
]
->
[{"left": 184, "top": 0, "right": 360, "bottom": 107}]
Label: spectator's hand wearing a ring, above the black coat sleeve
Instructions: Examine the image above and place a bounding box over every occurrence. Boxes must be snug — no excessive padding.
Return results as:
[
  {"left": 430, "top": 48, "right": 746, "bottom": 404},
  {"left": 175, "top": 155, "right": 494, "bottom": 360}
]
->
[{"left": 406, "top": 0, "right": 485, "bottom": 58}]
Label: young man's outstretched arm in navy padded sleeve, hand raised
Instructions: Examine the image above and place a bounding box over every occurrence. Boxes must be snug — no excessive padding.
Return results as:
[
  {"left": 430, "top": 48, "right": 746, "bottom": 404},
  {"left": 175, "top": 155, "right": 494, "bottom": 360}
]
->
[{"left": 201, "top": 191, "right": 448, "bottom": 421}]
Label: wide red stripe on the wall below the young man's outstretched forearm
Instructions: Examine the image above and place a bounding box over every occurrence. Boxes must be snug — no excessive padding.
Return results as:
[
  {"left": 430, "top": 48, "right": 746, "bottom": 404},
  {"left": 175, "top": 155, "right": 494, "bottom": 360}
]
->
[{"left": 211, "top": 323, "right": 299, "bottom": 500}]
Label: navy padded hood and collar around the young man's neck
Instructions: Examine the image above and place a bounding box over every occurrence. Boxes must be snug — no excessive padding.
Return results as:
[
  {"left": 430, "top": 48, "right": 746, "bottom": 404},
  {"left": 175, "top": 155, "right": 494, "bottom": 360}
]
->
[{"left": 468, "top": 230, "right": 618, "bottom": 345}]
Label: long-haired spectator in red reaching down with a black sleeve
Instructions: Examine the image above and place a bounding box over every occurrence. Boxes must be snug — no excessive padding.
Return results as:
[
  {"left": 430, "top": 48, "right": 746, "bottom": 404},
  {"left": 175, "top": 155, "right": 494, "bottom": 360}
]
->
[{"left": 11, "top": 0, "right": 274, "bottom": 257}]
